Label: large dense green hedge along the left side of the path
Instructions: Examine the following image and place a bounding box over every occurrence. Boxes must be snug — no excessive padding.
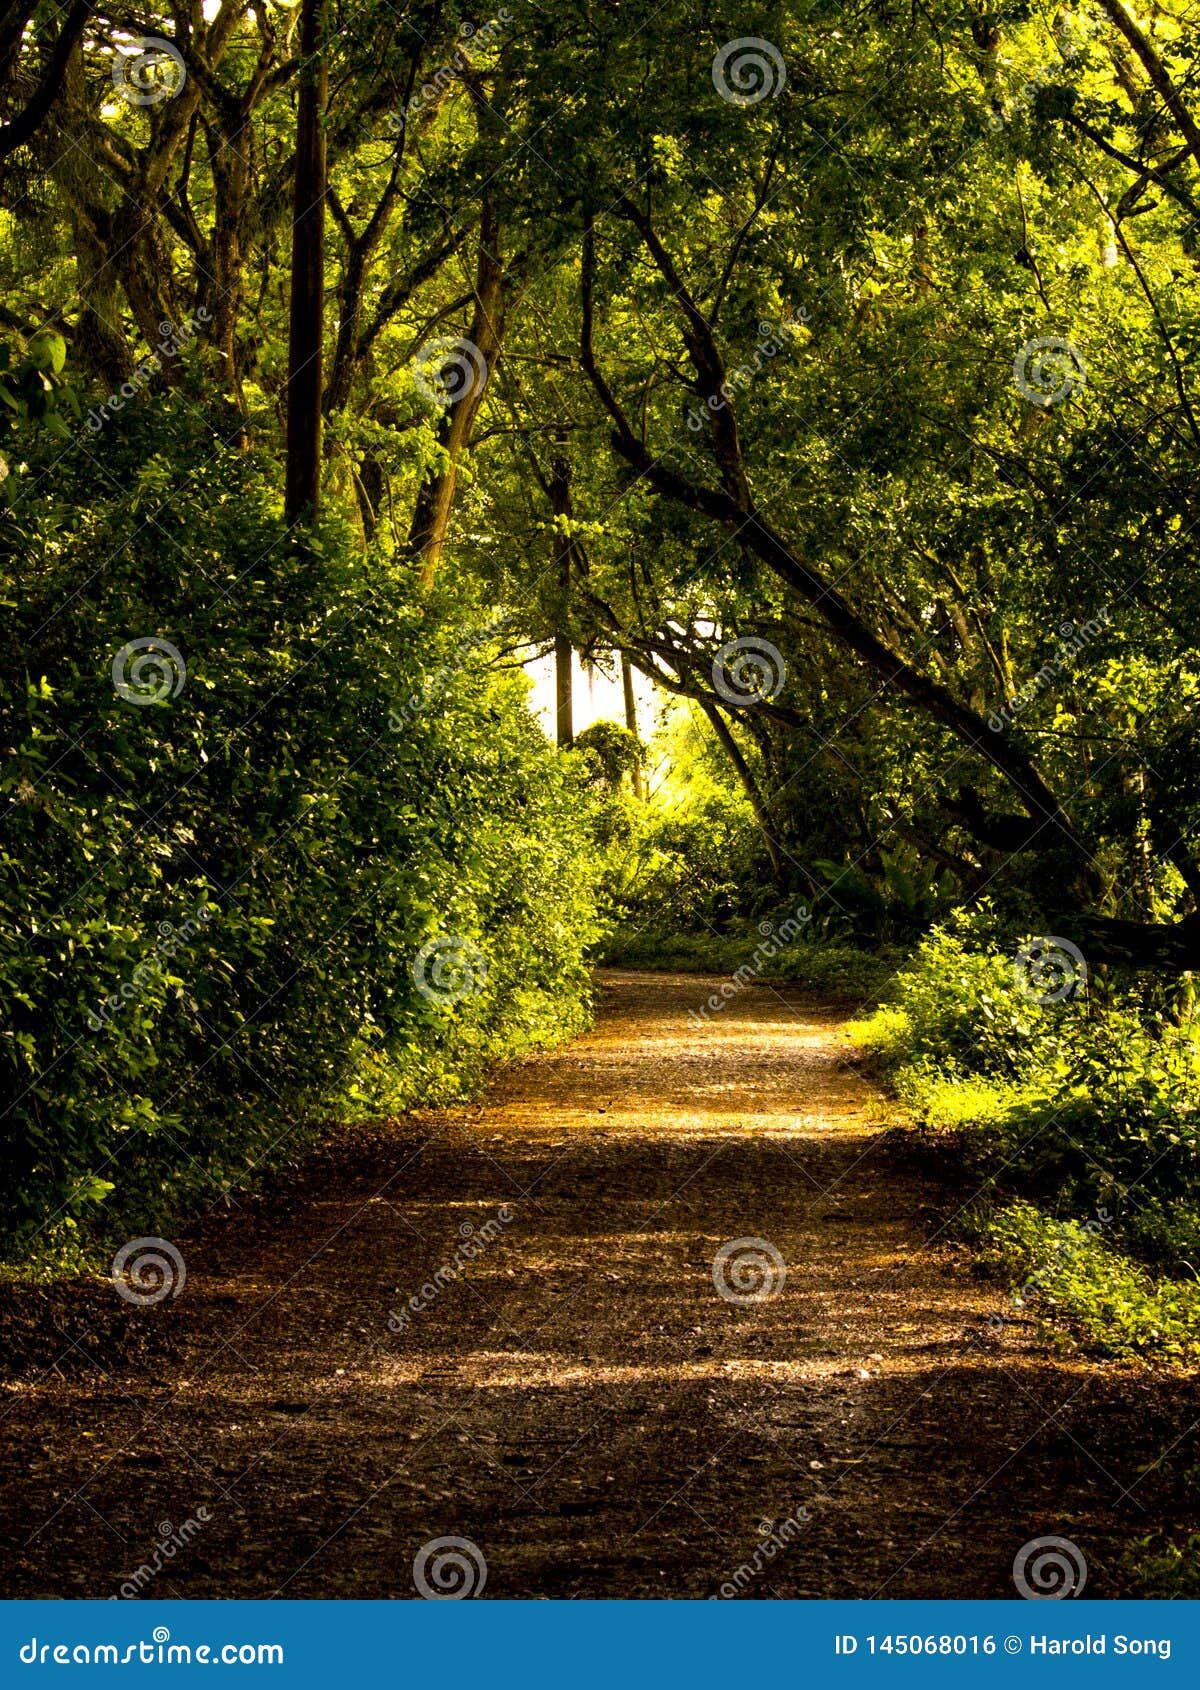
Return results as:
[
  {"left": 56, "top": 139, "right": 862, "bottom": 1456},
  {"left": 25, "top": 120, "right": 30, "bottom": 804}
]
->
[{"left": 0, "top": 399, "right": 595, "bottom": 1249}]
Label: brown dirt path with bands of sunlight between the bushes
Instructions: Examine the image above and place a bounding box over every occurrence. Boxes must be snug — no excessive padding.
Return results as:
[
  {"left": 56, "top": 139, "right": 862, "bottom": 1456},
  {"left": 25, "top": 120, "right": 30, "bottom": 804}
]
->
[{"left": 0, "top": 972, "right": 1197, "bottom": 1597}]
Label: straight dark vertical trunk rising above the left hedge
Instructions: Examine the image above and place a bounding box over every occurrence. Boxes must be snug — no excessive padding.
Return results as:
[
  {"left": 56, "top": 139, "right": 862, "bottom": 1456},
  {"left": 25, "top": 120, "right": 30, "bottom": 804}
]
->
[{"left": 284, "top": 0, "right": 328, "bottom": 522}]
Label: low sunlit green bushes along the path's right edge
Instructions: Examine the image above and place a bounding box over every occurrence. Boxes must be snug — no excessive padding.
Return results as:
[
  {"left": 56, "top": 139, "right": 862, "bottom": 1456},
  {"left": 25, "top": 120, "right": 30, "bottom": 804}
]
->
[{"left": 852, "top": 904, "right": 1200, "bottom": 1359}]
